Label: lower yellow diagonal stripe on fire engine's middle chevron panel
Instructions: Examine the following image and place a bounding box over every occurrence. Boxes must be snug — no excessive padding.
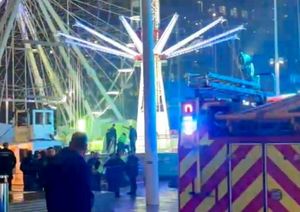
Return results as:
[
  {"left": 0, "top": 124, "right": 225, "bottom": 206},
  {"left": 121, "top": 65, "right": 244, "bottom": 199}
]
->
[{"left": 232, "top": 175, "right": 262, "bottom": 211}]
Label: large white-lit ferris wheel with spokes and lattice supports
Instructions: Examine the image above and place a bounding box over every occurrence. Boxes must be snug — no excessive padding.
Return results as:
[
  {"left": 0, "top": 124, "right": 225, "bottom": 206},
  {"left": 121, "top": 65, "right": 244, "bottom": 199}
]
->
[{"left": 0, "top": 0, "right": 138, "bottom": 127}]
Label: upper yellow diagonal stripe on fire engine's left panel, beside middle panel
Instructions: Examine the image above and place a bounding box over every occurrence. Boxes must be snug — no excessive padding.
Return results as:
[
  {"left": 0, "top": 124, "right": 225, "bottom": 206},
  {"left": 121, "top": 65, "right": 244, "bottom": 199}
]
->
[{"left": 202, "top": 145, "right": 226, "bottom": 184}]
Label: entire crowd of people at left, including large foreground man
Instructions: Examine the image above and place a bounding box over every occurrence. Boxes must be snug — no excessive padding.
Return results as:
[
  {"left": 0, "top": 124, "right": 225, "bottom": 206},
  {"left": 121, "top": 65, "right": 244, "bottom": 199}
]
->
[{"left": 0, "top": 124, "right": 139, "bottom": 212}]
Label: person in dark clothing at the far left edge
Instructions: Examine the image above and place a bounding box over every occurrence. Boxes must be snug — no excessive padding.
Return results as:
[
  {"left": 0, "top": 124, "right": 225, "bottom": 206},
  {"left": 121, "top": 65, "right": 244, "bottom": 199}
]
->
[{"left": 0, "top": 143, "right": 17, "bottom": 191}]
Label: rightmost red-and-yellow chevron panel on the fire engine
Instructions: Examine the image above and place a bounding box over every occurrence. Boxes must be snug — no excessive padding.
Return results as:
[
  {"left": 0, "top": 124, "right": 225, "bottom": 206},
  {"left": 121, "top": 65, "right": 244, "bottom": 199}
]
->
[{"left": 267, "top": 144, "right": 300, "bottom": 211}]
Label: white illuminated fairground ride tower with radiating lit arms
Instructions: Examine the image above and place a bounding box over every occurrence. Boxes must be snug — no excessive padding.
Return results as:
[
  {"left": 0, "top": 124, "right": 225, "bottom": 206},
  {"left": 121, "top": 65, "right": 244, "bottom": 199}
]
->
[{"left": 57, "top": 0, "right": 244, "bottom": 152}]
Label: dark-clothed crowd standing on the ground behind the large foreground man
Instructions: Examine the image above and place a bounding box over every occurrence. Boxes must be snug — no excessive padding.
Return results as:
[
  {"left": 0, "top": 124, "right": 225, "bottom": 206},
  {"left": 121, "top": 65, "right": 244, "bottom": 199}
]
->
[{"left": 20, "top": 142, "right": 138, "bottom": 197}]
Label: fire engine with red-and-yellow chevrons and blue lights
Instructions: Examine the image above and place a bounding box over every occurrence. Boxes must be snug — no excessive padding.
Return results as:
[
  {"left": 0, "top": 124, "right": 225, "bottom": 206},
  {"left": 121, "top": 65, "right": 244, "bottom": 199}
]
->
[{"left": 178, "top": 74, "right": 300, "bottom": 212}]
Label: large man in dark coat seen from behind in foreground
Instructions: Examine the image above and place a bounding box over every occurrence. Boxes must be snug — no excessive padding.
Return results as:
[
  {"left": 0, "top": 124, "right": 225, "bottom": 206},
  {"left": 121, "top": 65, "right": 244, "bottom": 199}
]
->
[{"left": 45, "top": 132, "right": 93, "bottom": 212}]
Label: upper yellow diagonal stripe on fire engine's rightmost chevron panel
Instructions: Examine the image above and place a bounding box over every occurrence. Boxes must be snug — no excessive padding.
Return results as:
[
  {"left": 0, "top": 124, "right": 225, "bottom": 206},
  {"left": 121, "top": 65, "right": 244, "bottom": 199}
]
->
[{"left": 268, "top": 146, "right": 300, "bottom": 187}]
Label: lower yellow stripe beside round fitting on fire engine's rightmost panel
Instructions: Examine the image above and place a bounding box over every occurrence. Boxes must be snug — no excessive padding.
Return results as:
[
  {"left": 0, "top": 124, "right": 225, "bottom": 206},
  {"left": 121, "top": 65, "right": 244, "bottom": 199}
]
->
[{"left": 268, "top": 175, "right": 300, "bottom": 211}]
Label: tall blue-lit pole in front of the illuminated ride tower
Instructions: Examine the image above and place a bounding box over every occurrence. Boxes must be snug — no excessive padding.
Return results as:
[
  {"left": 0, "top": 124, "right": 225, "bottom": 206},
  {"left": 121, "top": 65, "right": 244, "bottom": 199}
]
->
[{"left": 141, "top": 0, "right": 159, "bottom": 205}]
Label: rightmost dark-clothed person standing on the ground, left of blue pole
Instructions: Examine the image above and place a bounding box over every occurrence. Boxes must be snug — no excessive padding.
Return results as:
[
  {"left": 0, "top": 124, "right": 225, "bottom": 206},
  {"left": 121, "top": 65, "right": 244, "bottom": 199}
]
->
[{"left": 126, "top": 152, "right": 139, "bottom": 196}]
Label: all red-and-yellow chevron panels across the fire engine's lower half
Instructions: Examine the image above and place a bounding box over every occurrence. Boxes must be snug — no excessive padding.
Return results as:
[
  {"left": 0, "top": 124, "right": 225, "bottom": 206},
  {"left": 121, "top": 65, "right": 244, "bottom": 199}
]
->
[{"left": 180, "top": 141, "right": 300, "bottom": 212}]
